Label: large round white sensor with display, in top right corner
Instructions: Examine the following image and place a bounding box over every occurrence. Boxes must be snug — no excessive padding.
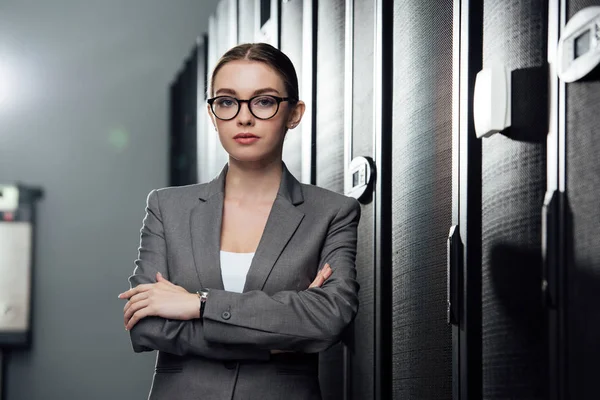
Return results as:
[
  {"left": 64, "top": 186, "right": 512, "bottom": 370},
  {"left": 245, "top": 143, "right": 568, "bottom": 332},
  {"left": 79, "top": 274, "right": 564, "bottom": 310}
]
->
[{"left": 556, "top": 6, "right": 600, "bottom": 82}]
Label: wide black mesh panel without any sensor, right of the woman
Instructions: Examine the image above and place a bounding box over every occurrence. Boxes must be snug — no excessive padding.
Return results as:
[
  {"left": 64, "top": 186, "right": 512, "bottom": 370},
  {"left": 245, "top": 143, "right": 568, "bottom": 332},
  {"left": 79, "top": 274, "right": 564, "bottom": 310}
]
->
[{"left": 392, "top": 0, "right": 453, "bottom": 400}]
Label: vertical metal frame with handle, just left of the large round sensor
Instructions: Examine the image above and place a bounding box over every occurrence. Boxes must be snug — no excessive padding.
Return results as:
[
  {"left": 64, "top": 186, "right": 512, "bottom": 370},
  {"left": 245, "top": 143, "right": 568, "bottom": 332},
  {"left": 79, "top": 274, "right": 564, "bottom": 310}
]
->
[{"left": 542, "top": 0, "right": 568, "bottom": 400}]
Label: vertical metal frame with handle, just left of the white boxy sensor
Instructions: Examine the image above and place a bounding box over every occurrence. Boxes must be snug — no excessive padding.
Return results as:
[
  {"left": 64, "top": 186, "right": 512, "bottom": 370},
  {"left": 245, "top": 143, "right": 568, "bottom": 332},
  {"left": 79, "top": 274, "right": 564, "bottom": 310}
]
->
[{"left": 449, "top": 0, "right": 483, "bottom": 400}]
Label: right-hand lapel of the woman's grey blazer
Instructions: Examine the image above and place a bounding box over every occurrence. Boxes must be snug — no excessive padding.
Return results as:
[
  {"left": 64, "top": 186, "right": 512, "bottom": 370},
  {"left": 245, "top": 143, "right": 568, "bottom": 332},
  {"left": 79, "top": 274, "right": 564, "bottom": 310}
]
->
[{"left": 244, "top": 163, "right": 304, "bottom": 292}]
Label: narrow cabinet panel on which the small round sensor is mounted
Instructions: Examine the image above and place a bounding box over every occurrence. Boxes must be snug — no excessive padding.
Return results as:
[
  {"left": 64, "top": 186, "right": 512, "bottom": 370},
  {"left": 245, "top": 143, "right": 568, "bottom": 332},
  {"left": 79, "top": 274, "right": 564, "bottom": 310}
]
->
[{"left": 344, "top": 1, "right": 376, "bottom": 399}]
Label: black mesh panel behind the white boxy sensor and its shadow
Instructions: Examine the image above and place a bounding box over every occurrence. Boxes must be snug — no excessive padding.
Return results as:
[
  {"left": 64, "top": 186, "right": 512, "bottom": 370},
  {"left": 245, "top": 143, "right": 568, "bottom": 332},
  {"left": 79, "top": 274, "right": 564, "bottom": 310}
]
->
[{"left": 482, "top": 0, "right": 548, "bottom": 399}]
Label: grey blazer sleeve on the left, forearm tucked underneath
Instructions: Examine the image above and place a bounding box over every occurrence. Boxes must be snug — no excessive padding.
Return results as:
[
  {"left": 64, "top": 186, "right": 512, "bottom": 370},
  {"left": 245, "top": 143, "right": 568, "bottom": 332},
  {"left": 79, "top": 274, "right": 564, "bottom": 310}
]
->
[{"left": 129, "top": 190, "right": 270, "bottom": 360}]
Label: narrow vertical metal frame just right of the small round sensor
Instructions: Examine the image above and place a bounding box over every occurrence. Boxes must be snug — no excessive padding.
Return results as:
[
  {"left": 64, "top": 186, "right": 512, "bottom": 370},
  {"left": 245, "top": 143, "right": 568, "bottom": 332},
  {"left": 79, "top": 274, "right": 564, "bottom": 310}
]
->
[{"left": 373, "top": 0, "right": 394, "bottom": 399}]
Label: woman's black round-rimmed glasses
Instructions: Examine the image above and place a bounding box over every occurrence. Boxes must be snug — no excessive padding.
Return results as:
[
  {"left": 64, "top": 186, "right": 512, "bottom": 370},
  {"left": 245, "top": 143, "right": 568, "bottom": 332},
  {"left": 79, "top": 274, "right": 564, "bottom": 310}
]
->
[{"left": 207, "top": 95, "right": 291, "bottom": 121}]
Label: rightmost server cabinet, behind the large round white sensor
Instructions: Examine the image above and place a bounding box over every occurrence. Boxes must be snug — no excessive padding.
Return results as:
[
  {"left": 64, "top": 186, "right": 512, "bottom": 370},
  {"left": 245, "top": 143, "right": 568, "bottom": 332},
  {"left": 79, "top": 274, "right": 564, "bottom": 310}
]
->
[{"left": 542, "top": 0, "right": 600, "bottom": 400}]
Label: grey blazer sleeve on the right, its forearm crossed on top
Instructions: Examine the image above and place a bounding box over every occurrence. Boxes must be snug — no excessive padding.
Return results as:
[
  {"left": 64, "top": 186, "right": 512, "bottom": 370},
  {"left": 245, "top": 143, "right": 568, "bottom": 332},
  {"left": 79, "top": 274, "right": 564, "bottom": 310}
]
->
[{"left": 202, "top": 198, "right": 360, "bottom": 353}]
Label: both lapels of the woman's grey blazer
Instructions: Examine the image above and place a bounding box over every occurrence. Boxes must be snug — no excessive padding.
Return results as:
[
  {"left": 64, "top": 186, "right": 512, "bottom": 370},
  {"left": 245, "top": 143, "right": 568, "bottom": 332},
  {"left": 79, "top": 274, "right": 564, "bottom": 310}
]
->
[{"left": 190, "top": 163, "right": 304, "bottom": 292}]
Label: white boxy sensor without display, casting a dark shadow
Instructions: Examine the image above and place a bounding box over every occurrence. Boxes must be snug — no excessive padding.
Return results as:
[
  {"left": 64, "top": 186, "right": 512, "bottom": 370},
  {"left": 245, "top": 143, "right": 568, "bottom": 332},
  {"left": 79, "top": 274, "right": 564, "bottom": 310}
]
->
[{"left": 473, "top": 65, "right": 511, "bottom": 138}]
